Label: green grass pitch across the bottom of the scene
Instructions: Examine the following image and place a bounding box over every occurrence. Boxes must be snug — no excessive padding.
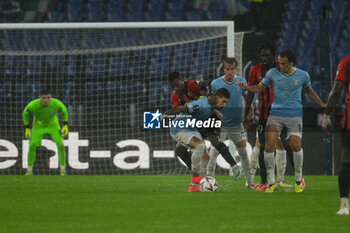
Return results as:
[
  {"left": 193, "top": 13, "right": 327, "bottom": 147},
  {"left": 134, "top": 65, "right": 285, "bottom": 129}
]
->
[{"left": 0, "top": 175, "right": 350, "bottom": 233}]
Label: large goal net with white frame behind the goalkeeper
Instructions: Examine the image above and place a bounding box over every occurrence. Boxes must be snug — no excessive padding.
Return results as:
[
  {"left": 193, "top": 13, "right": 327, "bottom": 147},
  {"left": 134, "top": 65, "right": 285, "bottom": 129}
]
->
[{"left": 0, "top": 22, "right": 241, "bottom": 174}]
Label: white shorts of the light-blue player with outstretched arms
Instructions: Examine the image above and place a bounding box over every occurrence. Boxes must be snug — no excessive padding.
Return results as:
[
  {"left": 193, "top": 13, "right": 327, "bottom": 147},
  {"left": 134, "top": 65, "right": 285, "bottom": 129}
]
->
[{"left": 266, "top": 115, "right": 303, "bottom": 138}]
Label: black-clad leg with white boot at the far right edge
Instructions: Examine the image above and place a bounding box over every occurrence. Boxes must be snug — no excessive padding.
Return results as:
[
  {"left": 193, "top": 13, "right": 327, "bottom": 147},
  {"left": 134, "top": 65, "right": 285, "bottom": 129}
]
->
[{"left": 337, "top": 130, "right": 350, "bottom": 215}]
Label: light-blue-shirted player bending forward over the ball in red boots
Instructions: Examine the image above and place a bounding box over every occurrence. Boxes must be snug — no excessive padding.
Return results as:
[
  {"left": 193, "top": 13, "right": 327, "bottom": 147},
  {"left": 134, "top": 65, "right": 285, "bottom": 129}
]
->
[{"left": 163, "top": 89, "right": 230, "bottom": 192}]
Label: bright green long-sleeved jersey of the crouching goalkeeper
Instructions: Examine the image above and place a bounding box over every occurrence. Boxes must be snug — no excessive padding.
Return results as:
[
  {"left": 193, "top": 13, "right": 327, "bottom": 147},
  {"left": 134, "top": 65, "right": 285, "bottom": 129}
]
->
[{"left": 23, "top": 98, "right": 68, "bottom": 127}]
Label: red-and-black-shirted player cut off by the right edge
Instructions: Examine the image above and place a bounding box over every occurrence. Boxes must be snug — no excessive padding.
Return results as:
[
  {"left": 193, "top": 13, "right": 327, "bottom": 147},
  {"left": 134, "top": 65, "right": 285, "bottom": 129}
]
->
[{"left": 322, "top": 56, "right": 350, "bottom": 215}]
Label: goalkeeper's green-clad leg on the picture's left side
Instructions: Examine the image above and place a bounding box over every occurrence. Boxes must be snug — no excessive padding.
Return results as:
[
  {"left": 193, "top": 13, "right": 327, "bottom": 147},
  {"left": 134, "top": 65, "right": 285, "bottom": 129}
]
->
[{"left": 26, "top": 127, "right": 46, "bottom": 175}]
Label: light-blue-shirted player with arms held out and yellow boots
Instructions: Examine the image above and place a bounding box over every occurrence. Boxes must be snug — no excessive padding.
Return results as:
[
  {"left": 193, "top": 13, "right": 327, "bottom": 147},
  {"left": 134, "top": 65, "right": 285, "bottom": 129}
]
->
[{"left": 239, "top": 49, "right": 325, "bottom": 193}]
